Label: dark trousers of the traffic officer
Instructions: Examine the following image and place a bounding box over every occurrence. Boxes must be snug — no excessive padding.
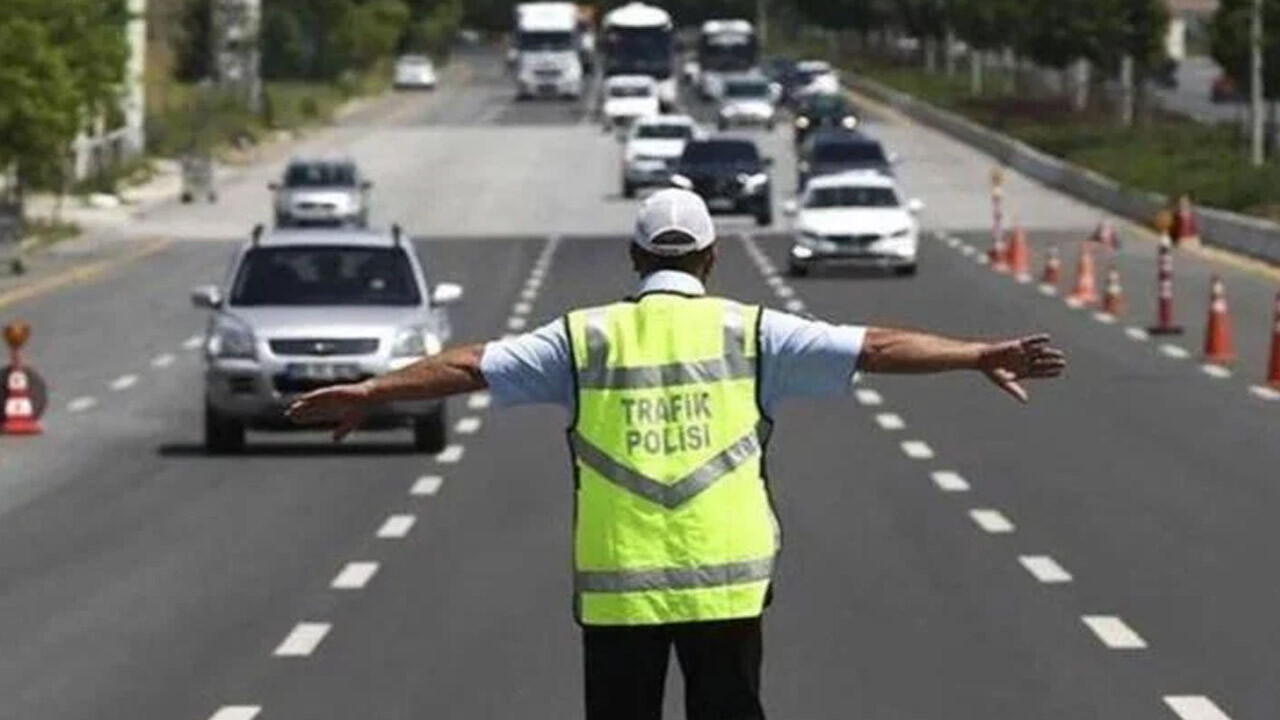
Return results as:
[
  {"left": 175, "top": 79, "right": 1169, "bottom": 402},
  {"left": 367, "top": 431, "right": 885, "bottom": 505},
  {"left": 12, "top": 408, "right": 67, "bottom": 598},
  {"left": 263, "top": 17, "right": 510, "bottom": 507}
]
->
[{"left": 582, "top": 618, "right": 764, "bottom": 720}]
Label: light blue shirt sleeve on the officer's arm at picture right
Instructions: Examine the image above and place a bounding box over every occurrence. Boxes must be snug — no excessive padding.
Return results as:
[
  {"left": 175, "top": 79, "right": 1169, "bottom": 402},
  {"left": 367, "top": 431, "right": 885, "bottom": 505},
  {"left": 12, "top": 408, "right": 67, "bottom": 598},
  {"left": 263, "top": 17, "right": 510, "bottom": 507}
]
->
[{"left": 760, "top": 310, "right": 867, "bottom": 414}]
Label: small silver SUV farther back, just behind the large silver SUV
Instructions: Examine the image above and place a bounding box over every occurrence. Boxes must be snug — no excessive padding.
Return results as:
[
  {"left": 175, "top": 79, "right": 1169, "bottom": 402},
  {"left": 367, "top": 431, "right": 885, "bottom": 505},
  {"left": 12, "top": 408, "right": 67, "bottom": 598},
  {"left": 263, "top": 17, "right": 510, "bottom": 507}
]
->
[{"left": 268, "top": 158, "right": 374, "bottom": 228}]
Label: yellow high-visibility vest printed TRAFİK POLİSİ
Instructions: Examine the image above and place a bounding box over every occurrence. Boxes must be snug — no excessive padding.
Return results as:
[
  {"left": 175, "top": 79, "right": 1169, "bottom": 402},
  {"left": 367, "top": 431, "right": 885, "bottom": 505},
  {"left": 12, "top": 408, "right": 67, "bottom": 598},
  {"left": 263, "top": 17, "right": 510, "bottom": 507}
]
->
[{"left": 568, "top": 293, "right": 780, "bottom": 625}]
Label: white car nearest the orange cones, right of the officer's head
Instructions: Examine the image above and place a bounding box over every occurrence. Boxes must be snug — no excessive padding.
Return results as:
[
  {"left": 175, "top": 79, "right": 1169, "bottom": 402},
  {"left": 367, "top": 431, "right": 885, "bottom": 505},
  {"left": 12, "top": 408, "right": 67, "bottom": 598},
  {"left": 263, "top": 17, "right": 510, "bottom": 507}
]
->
[{"left": 785, "top": 170, "right": 924, "bottom": 275}]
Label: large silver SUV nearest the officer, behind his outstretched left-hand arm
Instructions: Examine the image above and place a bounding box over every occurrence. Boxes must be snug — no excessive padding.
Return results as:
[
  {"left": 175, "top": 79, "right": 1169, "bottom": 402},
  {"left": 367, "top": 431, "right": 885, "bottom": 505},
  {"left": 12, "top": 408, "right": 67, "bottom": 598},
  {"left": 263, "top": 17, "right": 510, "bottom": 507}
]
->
[{"left": 191, "top": 225, "right": 462, "bottom": 454}]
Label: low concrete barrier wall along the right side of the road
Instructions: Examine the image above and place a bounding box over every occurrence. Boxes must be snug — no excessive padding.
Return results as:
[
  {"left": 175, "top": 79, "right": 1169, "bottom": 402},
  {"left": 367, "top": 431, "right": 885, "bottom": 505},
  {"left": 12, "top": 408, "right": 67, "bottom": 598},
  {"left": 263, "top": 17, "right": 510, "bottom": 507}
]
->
[{"left": 855, "top": 77, "right": 1280, "bottom": 264}]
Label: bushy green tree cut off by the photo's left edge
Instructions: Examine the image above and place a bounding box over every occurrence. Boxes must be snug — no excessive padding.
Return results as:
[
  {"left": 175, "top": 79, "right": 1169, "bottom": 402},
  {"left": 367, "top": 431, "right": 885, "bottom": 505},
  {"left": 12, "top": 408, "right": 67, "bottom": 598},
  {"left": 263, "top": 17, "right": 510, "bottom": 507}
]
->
[{"left": 0, "top": 18, "right": 82, "bottom": 212}]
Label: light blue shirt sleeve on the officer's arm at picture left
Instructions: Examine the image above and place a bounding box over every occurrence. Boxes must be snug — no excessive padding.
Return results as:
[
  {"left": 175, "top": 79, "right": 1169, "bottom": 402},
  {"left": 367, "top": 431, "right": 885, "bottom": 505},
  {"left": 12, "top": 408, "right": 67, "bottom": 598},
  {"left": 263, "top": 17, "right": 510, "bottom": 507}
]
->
[{"left": 480, "top": 319, "right": 576, "bottom": 413}]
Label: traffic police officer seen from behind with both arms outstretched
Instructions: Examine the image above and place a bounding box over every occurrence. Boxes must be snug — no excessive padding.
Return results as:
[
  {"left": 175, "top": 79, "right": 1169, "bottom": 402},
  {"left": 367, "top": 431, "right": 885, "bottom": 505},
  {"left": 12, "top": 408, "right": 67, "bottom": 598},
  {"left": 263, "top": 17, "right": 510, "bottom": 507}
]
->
[{"left": 289, "top": 190, "right": 1065, "bottom": 720}]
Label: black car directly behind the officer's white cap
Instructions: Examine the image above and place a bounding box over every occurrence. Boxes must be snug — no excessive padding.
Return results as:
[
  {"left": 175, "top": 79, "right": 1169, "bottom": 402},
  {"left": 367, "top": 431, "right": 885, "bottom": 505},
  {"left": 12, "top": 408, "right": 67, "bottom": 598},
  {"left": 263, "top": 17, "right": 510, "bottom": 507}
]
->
[{"left": 672, "top": 137, "right": 773, "bottom": 227}]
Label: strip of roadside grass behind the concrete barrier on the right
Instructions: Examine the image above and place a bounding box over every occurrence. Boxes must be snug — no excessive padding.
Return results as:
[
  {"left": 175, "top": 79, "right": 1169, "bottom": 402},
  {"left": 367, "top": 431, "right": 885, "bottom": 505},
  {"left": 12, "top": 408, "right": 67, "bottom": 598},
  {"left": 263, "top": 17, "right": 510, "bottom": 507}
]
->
[{"left": 845, "top": 59, "right": 1280, "bottom": 220}]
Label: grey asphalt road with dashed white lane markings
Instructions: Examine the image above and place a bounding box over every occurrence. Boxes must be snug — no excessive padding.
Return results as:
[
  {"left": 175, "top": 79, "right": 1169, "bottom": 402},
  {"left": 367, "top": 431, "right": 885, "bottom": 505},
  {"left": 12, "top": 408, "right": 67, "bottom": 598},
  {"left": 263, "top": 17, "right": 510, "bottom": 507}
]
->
[{"left": 0, "top": 50, "right": 1280, "bottom": 720}]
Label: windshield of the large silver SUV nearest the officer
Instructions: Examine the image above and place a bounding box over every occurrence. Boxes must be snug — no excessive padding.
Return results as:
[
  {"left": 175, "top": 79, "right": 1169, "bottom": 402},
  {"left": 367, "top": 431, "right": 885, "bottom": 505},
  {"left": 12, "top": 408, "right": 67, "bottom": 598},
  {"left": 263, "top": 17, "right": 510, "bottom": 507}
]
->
[{"left": 230, "top": 246, "right": 421, "bottom": 307}]
